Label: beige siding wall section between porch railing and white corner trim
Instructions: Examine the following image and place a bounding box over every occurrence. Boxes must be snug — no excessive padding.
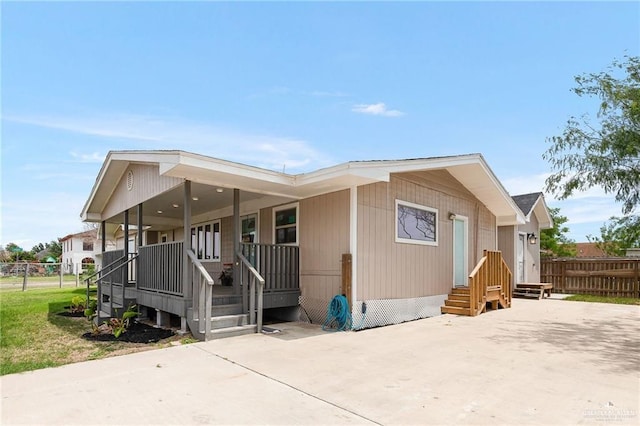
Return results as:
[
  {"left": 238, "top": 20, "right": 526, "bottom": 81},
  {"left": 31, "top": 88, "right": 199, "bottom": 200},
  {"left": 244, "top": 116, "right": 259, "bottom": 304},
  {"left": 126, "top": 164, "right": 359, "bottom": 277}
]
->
[{"left": 298, "top": 190, "right": 350, "bottom": 301}]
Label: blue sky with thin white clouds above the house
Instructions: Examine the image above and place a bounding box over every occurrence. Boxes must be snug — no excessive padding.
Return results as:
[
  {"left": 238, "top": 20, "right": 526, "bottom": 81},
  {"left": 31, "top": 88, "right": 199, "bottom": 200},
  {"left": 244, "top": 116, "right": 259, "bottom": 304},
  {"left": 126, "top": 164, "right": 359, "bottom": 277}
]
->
[{"left": 0, "top": 1, "right": 640, "bottom": 249}]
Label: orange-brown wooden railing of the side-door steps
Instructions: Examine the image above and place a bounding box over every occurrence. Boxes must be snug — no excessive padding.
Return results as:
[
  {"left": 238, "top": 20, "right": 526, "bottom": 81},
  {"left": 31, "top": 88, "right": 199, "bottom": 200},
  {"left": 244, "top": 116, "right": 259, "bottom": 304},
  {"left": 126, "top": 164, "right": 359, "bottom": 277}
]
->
[{"left": 469, "top": 250, "right": 512, "bottom": 316}]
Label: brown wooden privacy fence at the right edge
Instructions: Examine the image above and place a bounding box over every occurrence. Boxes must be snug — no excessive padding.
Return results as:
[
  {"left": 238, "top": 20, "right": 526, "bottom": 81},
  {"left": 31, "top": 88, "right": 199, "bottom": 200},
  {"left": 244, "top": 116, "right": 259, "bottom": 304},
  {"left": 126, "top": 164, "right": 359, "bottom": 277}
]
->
[{"left": 540, "top": 257, "right": 640, "bottom": 297}]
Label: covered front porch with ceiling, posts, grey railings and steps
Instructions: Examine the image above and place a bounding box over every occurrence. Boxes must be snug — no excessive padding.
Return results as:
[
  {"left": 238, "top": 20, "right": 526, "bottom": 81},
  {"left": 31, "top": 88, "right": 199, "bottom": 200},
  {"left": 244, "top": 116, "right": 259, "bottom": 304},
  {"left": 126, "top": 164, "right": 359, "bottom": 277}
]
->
[{"left": 88, "top": 173, "right": 300, "bottom": 340}]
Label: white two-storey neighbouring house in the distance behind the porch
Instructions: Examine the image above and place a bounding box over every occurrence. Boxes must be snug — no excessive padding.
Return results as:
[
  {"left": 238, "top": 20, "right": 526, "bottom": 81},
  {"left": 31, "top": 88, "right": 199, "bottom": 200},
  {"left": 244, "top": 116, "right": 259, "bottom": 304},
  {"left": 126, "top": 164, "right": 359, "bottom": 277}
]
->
[{"left": 58, "top": 230, "right": 113, "bottom": 274}]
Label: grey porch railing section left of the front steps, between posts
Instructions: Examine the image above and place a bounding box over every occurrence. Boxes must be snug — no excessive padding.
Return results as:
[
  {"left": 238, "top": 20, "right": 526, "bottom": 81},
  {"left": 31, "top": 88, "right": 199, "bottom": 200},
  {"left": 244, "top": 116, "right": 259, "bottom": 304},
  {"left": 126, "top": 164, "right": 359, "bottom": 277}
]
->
[{"left": 137, "top": 241, "right": 182, "bottom": 296}]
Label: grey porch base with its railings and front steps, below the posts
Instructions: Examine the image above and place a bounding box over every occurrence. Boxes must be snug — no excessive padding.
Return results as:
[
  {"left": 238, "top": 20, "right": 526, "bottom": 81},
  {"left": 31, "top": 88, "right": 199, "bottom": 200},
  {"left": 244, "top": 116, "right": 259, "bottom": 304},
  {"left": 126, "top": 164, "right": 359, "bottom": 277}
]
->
[{"left": 96, "top": 241, "right": 300, "bottom": 340}]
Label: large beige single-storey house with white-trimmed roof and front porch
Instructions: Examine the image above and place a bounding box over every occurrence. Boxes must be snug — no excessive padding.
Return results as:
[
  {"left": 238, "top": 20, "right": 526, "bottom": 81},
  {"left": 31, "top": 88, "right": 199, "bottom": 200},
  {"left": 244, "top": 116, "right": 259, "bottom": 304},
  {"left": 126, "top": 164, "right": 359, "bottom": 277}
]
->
[{"left": 81, "top": 151, "right": 524, "bottom": 338}]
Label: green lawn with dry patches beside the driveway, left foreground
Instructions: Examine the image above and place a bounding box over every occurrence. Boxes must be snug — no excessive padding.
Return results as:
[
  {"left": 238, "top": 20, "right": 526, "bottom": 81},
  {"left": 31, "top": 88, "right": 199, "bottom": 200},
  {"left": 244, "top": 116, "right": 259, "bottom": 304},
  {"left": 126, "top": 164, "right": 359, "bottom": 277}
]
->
[{"left": 0, "top": 287, "right": 181, "bottom": 375}]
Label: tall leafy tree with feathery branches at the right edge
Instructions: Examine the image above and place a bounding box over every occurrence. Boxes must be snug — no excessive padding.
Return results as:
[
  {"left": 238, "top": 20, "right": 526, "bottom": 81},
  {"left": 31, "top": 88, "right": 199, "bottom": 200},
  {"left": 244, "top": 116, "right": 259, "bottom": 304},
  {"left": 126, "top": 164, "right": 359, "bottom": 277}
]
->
[{"left": 543, "top": 56, "right": 640, "bottom": 215}]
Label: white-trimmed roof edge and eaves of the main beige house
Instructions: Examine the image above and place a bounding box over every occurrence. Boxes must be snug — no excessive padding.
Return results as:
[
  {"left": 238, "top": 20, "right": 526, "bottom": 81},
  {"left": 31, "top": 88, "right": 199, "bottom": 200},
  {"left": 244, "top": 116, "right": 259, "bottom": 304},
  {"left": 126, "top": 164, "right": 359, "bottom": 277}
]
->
[{"left": 81, "top": 150, "right": 525, "bottom": 225}]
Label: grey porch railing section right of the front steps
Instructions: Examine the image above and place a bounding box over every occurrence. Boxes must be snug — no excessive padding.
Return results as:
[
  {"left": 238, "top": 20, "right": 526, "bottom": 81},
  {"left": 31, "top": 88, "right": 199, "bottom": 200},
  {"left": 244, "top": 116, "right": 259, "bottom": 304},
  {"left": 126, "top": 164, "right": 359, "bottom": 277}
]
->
[{"left": 241, "top": 243, "right": 300, "bottom": 293}]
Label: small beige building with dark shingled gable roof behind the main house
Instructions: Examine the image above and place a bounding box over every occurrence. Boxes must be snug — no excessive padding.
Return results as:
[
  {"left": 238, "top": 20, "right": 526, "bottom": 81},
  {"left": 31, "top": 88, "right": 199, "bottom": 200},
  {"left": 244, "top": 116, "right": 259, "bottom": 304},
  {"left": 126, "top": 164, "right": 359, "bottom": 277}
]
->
[{"left": 498, "top": 192, "right": 553, "bottom": 286}]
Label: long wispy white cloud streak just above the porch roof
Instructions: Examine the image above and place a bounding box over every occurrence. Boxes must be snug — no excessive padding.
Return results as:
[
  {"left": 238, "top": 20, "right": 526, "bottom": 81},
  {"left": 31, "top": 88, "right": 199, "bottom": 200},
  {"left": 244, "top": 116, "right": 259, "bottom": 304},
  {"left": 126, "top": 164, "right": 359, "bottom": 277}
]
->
[{"left": 5, "top": 114, "right": 331, "bottom": 172}]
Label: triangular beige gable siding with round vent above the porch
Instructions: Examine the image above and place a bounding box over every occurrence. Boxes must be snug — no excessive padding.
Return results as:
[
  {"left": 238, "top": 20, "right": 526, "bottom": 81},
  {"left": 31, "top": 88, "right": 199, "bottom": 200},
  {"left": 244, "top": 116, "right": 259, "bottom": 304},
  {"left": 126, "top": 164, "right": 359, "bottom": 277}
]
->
[{"left": 102, "top": 164, "right": 182, "bottom": 219}]
